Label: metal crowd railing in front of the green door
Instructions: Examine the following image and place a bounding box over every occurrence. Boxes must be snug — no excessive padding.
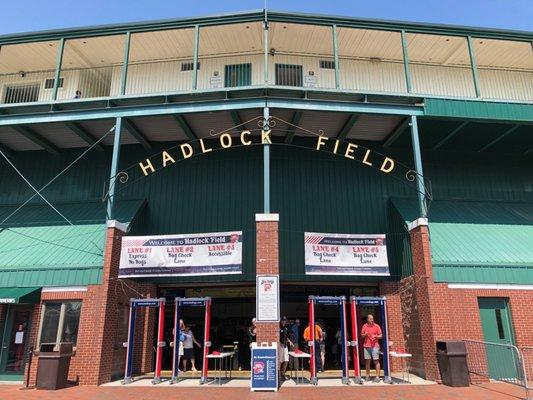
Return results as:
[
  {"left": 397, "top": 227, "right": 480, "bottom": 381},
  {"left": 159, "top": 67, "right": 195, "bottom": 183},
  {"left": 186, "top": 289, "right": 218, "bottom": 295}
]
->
[{"left": 463, "top": 340, "right": 530, "bottom": 399}]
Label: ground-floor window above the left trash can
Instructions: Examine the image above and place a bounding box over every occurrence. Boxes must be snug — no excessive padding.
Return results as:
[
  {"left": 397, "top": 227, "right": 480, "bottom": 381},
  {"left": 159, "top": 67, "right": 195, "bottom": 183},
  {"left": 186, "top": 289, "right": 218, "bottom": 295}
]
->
[{"left": 37, "top": 301, "right": 81, "bottom": 345}]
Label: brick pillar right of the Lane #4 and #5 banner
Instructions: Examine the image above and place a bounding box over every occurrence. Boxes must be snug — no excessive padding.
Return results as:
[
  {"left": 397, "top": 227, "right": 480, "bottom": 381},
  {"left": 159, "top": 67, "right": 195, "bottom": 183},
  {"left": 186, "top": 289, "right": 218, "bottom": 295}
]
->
[{"left": 408, "top": 218, "right": 439, "bottom": 380}]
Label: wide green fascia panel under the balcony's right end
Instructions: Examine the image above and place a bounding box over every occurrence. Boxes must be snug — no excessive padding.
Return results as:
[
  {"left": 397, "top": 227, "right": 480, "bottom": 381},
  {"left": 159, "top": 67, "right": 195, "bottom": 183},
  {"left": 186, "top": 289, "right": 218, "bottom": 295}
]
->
[{"left": 424, "top": 98, "right": 533, "bottom": 122}]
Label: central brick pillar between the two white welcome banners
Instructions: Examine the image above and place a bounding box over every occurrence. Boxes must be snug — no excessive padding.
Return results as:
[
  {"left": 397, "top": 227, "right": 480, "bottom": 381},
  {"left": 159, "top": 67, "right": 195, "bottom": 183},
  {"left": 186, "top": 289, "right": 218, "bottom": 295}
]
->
[{"left": 255, "top": 214, "right": 279, "bottom": 343}]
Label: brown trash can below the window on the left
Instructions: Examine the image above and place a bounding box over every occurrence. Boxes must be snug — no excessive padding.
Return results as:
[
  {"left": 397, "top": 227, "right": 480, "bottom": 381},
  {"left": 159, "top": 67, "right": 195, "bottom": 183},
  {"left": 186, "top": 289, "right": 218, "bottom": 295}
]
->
[{"left": 36, "top": 343, "right": 72, "bottom": 390}]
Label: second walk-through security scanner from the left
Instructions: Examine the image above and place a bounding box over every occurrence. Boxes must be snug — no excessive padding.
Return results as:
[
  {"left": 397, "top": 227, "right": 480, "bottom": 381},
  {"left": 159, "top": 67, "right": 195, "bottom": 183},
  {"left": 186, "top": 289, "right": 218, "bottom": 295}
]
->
[{"left": 170, "top": 297, "right": 211, "bottom": 384}]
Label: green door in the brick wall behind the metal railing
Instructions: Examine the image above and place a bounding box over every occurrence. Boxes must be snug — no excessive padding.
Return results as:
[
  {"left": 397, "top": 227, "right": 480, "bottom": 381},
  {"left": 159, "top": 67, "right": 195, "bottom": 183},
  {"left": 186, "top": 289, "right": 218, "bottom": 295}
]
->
[{"left": 478, "top": 297, "right": 518, "bottom": 380}]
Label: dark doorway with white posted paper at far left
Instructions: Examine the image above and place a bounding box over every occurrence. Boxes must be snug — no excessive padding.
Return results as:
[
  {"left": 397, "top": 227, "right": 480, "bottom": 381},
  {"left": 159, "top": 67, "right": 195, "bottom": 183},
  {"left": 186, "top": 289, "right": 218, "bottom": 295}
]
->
[{"left": 0, "top": 305, "right": 33, "bottom": 380}]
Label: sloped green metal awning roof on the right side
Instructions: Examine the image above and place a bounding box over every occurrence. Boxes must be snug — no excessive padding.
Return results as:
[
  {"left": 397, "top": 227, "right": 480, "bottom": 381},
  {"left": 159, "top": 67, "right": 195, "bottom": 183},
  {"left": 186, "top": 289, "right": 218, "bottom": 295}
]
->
[{"left": 393, "top": 199, "right": 533, "bottom": 284}]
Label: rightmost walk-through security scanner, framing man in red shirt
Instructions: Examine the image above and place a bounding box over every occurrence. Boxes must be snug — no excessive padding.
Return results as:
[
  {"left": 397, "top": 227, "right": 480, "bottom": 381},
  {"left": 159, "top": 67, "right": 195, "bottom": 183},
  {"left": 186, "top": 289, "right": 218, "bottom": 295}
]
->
[{"left": 350, "top": 296, "right": 392, "bottom": 383}]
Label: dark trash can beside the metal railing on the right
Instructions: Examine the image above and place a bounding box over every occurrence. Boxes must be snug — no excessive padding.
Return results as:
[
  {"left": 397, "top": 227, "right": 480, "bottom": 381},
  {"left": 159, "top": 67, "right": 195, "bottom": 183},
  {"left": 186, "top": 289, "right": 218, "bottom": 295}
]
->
[{"left": 437, "top": 341, "right": 470, "bottom": 387}]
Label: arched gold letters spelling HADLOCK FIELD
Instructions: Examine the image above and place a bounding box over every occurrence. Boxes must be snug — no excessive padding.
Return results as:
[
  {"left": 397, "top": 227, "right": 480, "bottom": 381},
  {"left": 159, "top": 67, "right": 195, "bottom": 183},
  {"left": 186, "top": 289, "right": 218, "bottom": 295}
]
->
[{"left": 135, "top": 130, "right": 396, "bottom": 176}]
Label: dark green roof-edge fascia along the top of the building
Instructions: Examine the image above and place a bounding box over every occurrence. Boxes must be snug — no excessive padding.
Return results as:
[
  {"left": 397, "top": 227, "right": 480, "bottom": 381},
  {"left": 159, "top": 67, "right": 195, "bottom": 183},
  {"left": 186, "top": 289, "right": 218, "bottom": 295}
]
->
[{"left": 0, "top": 10, "right": 533, "bottom": 45}]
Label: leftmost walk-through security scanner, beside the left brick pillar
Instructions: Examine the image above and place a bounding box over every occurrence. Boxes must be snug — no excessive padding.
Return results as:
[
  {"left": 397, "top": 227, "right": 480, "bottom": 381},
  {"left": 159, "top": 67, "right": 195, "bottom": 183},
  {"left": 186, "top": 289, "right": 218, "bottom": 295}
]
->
[{"left": 122, "top": 297, "right": 165, "bottom": 385}]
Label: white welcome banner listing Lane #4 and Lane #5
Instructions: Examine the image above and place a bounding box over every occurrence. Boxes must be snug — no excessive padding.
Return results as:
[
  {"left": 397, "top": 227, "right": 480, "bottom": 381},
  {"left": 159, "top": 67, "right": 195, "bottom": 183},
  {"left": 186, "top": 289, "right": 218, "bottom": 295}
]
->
[{"left": 304, "top": 232, "right": 390, "bottom": 276}]
